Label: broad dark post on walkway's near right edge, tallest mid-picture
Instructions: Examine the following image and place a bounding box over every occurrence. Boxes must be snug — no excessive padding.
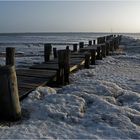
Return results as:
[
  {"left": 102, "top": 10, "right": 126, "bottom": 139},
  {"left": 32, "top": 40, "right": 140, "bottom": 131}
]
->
[{"left": 57, "top": 50, "right": 70, "bottom": 85}]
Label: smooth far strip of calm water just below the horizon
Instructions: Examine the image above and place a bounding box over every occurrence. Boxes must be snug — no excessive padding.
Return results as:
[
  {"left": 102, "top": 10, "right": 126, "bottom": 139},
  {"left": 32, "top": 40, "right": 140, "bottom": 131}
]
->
[{"left": 0, "top": 33, "right": 140, "bottom": 44}]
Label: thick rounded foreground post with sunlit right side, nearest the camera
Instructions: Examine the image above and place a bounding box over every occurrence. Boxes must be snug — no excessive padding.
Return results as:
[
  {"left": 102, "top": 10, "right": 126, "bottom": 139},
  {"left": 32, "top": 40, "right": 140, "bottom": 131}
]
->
[{"left": 0, "top": 65, "right": 21, "bottom": 121}]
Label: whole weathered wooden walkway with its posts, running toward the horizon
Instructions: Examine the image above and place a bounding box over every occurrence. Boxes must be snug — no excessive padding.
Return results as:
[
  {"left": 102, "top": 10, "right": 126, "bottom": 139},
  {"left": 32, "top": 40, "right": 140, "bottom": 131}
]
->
[{"left": 0, "top": 35, "right": 121, "bottom": 119}]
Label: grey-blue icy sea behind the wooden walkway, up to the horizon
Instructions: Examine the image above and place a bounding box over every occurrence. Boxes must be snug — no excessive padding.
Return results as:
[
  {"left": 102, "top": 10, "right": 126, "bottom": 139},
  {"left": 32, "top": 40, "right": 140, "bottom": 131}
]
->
[{"left": 0, "top": 32, "right": 140, "bottom": 67}]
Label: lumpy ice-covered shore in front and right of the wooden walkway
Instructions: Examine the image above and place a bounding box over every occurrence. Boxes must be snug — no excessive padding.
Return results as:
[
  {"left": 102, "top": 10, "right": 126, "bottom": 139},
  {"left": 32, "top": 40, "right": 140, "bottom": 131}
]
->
[{"left": 0, "top": 37, "right": 140, "bottom": 139}]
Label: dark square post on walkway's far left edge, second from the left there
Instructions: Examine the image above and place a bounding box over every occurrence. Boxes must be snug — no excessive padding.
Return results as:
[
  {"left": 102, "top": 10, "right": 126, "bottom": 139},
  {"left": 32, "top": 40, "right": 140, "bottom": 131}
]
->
[{"left": 44, "top": 44, "right": 52, "bottom": 62}]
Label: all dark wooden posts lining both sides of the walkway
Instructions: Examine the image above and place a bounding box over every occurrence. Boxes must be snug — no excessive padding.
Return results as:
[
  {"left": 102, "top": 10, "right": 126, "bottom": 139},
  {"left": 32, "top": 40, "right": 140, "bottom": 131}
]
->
[{"left": 0, "top": 35, "right": 121, "bottom": 121}]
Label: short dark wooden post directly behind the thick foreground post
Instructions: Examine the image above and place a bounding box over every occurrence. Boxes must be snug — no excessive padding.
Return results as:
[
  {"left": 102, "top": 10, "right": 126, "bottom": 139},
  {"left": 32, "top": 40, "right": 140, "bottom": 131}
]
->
[{"left": 6, "top": 47, "right": 15, "bottom": 65}]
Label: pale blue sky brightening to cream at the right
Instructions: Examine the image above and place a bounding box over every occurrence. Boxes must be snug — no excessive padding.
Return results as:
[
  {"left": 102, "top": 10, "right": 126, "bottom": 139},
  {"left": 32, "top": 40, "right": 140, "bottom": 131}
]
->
[{"left": 0, "top": 0, "right": 140, "bottom": 33}]
